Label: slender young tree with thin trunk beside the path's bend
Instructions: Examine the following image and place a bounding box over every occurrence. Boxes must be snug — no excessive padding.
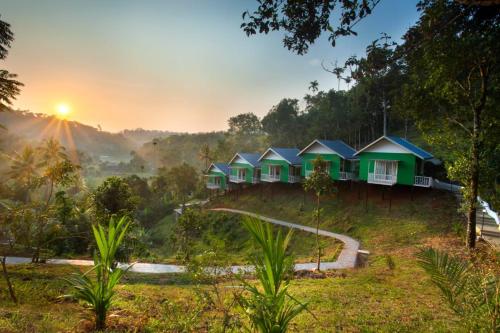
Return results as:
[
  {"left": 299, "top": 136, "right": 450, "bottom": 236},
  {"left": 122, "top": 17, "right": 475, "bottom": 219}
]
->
[{"left": 303, "top": 156, "right": 334, "bottom": 271}]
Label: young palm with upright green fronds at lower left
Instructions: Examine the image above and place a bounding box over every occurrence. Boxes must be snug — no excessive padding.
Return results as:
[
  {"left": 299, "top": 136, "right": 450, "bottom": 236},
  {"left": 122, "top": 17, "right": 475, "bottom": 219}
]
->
[{"left": 66, "top": 217, "right": 130, "bottom": 330}]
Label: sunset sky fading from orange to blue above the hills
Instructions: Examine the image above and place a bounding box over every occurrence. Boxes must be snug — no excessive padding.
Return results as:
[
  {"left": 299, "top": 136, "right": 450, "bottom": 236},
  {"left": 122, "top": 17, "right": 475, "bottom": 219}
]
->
[{"left": 0, "top": 0, "right": 418, "bottom": 132}]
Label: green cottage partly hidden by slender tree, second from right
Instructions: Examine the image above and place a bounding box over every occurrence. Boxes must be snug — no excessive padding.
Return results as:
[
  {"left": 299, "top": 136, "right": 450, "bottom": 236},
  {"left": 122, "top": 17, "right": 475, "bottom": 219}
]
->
[{"left": 299, "top": 140, "right": 358, "bottom": 180}]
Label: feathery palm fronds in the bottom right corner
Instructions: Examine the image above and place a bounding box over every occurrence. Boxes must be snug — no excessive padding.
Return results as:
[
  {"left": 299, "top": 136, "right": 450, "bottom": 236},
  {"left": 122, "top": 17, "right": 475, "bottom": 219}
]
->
[{"left": 418, "top": 248, "right": 500, "bottom": 333}]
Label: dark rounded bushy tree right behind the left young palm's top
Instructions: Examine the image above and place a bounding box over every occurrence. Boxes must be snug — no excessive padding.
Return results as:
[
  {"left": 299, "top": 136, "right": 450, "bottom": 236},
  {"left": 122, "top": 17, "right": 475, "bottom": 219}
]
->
[{"left": 93, "top": 177, "right": 137, "bottom": 221}]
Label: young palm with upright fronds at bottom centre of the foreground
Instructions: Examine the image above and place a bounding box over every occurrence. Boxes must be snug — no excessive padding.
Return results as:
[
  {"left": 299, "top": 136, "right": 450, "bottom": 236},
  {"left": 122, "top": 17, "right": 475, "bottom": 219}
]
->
[{"left": 239, "top": 219, "right": 307, "bottom": 333}]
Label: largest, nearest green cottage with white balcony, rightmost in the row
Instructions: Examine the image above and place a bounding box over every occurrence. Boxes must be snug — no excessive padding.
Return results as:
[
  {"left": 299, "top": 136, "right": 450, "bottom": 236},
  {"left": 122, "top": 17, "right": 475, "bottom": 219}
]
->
[{"left": 355, "top": 136, "right": 433, "bottom": 187}]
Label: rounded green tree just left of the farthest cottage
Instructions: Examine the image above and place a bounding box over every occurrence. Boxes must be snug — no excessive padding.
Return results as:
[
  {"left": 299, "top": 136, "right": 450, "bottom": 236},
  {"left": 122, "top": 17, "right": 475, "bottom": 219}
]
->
[{"left": 167, "top": 163, "right": 198, "bottom": 207}]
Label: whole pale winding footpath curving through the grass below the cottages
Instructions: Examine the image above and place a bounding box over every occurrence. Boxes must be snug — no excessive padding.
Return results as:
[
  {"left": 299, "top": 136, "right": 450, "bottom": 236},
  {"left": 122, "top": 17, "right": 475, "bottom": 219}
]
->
[{"left": 6, "top": 208, "right": 359, "bottom": 273}]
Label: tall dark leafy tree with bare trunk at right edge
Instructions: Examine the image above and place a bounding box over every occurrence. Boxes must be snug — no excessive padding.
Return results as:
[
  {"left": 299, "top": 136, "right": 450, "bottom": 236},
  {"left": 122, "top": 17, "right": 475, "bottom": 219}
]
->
[{"left": 402, "top": 0, "right": 500, "bottom": 248}]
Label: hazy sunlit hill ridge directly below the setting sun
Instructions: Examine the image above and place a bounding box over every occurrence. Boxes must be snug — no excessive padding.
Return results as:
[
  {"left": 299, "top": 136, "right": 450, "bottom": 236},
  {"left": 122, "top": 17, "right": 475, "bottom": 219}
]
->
[{"left": 0, "top": 110, "right": 136, "bottom": 160}]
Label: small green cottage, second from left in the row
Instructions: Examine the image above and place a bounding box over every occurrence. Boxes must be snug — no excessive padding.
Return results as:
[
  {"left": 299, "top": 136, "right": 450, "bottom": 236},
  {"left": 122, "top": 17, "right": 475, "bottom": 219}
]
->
[{"left": 229, "top": 153, "right": 260, "bottom": 184}]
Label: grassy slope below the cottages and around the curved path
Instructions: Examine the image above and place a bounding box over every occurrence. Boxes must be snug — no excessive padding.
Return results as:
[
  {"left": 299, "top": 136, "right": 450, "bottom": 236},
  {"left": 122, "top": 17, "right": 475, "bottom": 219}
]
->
[{"left": 0, "top": 183, "right": 478, "bottom": 332}]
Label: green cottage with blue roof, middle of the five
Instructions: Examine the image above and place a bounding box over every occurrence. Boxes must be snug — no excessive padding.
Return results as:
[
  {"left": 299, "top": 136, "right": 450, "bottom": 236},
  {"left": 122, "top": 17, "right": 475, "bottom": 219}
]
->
[{"left": 259, "top": 148, "right": 302, "bottom": 183}]
